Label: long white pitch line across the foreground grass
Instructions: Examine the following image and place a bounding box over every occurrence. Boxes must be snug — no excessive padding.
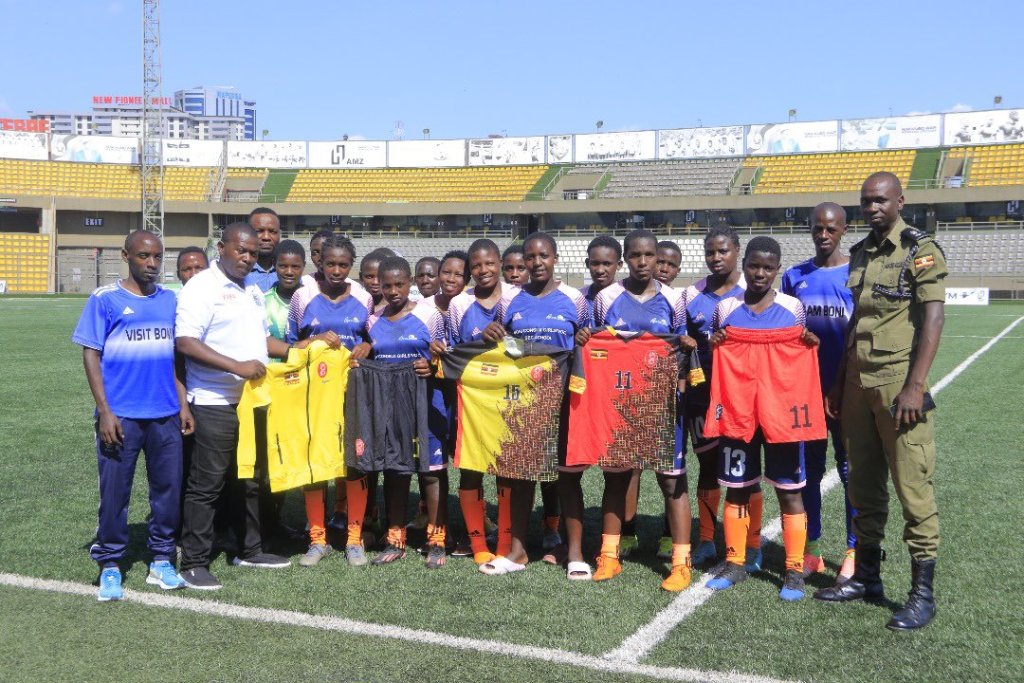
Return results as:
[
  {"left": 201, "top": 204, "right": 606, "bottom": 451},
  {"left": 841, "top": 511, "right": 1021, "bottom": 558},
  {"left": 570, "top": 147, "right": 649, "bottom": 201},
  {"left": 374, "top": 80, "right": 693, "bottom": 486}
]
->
[{"left": 0, "top": 572, "right": 785, "bottom": 683}]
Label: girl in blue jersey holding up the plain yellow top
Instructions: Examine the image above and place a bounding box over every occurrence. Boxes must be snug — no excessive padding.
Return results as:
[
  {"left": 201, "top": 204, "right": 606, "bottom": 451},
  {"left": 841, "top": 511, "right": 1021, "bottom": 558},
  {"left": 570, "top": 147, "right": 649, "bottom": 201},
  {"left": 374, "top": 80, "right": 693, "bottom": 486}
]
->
[{"left": 286, "top": 234, "right": 373, "bottom": 566}]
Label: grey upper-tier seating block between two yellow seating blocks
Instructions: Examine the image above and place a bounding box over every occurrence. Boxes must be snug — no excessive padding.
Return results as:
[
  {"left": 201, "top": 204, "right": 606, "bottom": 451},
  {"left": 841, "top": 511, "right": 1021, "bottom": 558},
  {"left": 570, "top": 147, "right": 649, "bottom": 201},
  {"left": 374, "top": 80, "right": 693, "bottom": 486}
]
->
[{"left": 568, "top": 159, "right": 739, "bottom": 199}]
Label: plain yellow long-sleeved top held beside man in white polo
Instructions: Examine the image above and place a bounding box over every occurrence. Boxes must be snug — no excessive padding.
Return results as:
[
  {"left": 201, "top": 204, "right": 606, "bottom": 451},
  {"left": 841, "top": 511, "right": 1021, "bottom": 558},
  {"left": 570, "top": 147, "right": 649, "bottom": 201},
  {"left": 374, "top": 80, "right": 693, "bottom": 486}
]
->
[{"left": 238, "top": 342, "right": 351, "bottom": 492}]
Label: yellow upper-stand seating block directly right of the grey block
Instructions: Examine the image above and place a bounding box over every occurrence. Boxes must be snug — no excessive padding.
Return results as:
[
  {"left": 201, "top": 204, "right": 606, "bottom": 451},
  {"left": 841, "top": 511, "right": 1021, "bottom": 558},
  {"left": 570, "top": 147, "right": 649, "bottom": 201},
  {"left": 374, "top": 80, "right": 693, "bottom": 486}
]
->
[{"left": 743, "top": 150, "right": 915, "bottom": 195}]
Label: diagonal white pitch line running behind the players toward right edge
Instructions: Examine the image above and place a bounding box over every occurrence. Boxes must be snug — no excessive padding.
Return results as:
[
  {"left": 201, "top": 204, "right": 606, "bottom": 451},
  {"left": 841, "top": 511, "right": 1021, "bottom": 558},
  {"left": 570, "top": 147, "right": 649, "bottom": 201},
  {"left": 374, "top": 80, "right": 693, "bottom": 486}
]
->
[{"left": 604, "top": 316, "right": 1024, "bottom": 663}]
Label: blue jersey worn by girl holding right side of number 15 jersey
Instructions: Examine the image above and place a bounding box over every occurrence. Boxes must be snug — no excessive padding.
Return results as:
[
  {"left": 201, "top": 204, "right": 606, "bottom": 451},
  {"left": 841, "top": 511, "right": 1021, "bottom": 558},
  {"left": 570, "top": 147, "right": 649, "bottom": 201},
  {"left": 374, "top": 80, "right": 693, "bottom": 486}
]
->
[{"left": 498, "top": 284, "right": 590, "bottom": 349}]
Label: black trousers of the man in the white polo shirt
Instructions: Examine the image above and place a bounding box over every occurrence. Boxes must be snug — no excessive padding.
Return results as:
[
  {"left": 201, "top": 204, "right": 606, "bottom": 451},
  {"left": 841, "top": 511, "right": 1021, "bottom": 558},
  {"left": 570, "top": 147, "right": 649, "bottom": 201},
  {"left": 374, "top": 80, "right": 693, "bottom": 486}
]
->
[{"left": 181, "top": 404, "right": 265, "bottom": 570}]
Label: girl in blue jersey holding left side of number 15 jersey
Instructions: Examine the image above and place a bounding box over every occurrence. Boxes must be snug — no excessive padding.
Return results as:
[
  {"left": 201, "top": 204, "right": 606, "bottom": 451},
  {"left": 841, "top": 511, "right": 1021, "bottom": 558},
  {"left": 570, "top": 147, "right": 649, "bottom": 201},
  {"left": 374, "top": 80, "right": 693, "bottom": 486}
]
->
[{"left": 435, "top": 239, "right": 519, "bottom": 564}]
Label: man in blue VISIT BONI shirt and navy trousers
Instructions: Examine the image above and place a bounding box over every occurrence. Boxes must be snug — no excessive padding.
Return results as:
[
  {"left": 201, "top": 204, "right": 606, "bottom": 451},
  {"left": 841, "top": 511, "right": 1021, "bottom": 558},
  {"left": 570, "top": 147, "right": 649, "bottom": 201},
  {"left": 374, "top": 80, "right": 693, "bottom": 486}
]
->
[{"left": 72, "top": 230, "right": 194, "bottom": 602}]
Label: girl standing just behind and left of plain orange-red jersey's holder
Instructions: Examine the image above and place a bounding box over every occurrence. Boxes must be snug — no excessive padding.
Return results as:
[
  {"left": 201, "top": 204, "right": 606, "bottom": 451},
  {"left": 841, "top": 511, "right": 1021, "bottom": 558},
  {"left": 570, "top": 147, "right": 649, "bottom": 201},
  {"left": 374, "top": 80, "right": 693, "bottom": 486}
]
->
[{"left": 683, "top": 226, "right": 764, "bottom": 571}]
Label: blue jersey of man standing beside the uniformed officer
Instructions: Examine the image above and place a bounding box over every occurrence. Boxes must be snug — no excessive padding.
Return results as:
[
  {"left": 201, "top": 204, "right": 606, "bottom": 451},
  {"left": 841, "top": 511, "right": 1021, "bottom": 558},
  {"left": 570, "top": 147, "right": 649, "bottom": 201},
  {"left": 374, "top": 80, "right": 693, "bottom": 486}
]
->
[{"left": 782, "top": 259, "right": 853, "bottom": 393}]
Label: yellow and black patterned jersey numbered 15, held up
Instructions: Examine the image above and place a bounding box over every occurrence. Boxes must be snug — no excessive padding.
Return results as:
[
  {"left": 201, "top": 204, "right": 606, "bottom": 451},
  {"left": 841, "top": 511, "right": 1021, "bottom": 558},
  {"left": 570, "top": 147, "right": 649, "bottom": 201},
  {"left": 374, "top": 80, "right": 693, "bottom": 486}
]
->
[{"left": 438, "top": 338, "right": 571, "bottom": 481}]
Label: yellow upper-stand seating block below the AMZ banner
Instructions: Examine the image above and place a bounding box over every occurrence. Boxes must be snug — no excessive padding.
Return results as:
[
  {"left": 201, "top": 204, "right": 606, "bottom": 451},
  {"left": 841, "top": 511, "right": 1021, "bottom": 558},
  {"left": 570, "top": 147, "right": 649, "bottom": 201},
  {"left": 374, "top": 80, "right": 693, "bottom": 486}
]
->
[{"left": 286, "top": 166, "right": 548, "bottom": 203}]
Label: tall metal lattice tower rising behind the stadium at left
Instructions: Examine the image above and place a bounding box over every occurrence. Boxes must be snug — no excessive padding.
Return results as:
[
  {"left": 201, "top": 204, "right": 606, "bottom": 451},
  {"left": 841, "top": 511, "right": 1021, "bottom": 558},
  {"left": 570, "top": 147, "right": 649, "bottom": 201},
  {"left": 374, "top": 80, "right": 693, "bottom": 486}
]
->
[{"left": 139, "top": 0, "right": 164, "bottom": 239}]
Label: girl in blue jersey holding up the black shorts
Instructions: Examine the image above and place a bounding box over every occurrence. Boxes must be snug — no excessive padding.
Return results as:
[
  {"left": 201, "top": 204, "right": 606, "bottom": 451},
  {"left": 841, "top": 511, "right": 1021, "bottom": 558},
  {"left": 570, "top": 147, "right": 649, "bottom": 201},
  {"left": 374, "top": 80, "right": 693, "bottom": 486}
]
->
[{"left": 345, "top": 256, "right": 444, "bottom": 565}]
